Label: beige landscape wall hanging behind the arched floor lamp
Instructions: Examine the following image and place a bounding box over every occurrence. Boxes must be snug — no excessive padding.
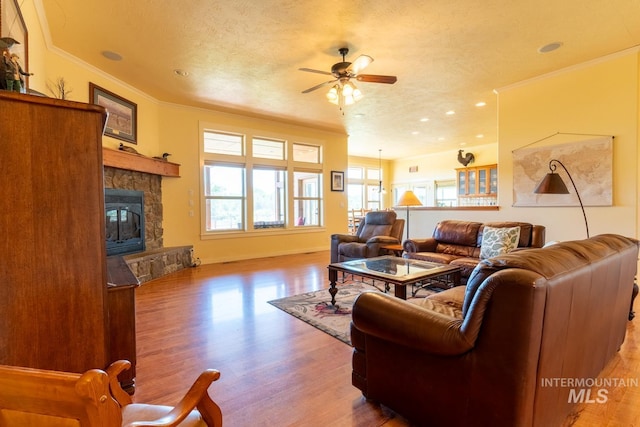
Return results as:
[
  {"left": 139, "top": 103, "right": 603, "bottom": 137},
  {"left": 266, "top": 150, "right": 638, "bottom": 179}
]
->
[{"left": 513, "top": 136, "right": 613, "bottom": 206}]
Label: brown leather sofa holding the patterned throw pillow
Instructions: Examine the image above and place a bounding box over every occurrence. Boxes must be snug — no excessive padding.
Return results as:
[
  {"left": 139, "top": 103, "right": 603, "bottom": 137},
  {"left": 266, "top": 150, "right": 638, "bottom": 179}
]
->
[{"left": 402, "top": 220, "right": 546, "bottom": 283}]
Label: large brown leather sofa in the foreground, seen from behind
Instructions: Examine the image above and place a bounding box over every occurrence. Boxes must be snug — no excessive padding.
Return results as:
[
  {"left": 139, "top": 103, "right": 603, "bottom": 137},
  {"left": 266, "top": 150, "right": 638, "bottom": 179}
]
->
[{"left": 351, "top": 234, "right": 638, "bottom": 427}]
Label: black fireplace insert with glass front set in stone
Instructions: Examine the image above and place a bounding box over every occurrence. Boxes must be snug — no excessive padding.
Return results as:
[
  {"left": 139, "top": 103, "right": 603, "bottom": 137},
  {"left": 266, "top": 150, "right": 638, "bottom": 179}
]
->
[{"left": 104, "top": 188, "right": 145, "bottom": 256}]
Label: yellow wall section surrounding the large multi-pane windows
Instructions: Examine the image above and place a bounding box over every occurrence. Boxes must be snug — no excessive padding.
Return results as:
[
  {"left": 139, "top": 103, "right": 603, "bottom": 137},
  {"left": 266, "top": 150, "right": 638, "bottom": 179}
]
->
[{"left": 159, "top": 104, "right": 347, "bottom": 263}]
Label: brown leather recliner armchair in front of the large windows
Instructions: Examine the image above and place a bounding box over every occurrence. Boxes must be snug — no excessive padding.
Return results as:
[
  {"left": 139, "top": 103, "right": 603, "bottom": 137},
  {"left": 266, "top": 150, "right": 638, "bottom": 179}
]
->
[{"left": 331, "top": 211, "right": 404, "bottom": 264}]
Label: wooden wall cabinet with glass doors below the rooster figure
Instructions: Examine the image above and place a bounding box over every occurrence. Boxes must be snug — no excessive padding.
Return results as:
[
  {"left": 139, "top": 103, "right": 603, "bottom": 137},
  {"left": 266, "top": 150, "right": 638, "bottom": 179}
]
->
[{"left": 456, "top": 165, "right": 498, "bottom": 205}]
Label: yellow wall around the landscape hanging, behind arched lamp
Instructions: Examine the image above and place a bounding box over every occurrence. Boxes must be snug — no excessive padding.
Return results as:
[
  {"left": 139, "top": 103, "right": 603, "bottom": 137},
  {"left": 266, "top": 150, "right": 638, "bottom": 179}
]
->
[{"left": 498, "top": 49, "right": 639, "bottom": 244}]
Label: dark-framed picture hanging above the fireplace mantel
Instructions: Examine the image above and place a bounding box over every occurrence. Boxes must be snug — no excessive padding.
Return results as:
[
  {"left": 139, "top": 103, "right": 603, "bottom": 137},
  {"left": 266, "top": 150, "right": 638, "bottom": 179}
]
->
[{"left": 89, "top": 82, "right": 138, "bottom": 144}]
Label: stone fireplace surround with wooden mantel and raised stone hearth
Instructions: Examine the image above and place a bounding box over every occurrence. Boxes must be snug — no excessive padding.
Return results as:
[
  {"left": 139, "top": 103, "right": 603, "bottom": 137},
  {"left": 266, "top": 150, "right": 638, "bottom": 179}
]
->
[{"left": 103, "top": 148, "right": 193, "bottom": 283}]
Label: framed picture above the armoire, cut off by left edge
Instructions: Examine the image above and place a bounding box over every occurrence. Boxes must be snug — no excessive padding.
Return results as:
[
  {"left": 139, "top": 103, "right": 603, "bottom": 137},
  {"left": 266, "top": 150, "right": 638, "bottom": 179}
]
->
[{"left": 0, "top": 0, "right": 29, "bottom": 91}]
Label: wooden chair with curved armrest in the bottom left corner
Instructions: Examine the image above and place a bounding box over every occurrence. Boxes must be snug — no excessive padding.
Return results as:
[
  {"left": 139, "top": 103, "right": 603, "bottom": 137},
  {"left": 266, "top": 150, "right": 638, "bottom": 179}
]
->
[{"left": 0, "top": 360, "right": 222, "bottom": 427}]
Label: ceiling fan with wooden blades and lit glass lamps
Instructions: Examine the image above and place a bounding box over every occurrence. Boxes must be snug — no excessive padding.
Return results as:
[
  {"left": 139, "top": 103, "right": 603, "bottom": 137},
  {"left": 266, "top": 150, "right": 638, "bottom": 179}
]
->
[{"left": 299, "top": 47, "right": 398, "bottom": 106}]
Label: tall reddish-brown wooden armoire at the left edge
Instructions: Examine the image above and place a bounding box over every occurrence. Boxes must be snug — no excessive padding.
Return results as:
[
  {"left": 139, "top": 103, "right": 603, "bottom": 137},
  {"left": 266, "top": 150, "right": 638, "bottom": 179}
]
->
[{"left": 0, "top": 91, "right": 113, "bottom": 378}]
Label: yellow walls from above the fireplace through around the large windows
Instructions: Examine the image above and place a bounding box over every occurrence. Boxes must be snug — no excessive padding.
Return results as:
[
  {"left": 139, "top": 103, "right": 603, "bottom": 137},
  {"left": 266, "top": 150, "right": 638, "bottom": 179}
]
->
[{"left": 21, "top": 0, "right": 347, "bottom": 263}]
